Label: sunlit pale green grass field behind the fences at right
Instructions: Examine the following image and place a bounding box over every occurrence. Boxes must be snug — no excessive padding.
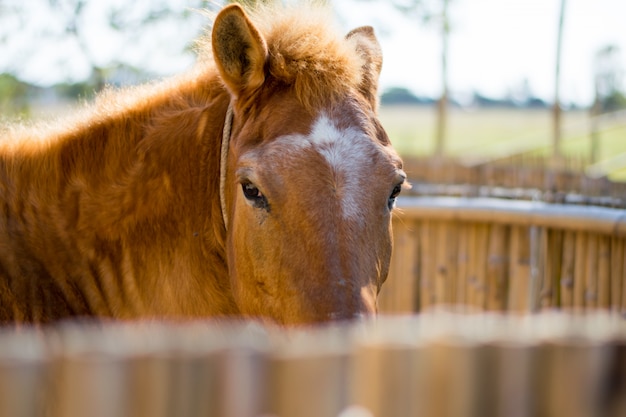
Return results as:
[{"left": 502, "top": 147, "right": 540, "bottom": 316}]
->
[{"left": 380, "top": 106, "right": 626, "bottom": 181}]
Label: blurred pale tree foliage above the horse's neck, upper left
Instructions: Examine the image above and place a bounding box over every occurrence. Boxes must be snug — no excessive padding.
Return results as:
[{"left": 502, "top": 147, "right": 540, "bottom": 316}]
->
[{"left": 0, "top": 0, "right": 210, "bottom": 89}]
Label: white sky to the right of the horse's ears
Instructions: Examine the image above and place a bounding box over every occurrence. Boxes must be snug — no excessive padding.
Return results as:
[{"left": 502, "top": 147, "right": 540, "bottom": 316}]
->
[{"left": 334, "top": 0, "right": 626, "bottom": 105}]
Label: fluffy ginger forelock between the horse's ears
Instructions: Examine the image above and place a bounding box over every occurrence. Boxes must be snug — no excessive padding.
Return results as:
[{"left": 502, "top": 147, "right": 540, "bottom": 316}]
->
[{"left": 197, "top": 2, "right": 364, "bottom": 110}]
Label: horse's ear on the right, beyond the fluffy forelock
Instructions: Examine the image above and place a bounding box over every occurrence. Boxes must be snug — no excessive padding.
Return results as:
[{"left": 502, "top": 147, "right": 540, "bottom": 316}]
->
[{"left": 346, "top": 26, "right": 383, "bottom": 109}]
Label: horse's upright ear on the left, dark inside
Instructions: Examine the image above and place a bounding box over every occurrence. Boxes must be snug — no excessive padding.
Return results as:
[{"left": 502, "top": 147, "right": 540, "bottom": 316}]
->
[{"left": 211, "top": 4, "right": 268, "bottom": 97}]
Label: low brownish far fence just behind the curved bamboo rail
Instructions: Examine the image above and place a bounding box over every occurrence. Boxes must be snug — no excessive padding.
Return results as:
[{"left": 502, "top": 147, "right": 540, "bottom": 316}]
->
[{"left": 405, "top": 155, "right": 626, "bottom": 208}]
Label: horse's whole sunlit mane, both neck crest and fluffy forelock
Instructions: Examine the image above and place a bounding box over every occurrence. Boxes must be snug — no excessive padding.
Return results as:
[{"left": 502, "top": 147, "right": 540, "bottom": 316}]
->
[{"left": 0, "top": 2, "right": 363, "bottom": 151}]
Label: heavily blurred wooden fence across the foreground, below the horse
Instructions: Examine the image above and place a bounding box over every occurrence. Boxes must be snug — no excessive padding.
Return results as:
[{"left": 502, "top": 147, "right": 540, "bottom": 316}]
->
[{"left": 0, "top": 313, "right": 626, "bottom": 417}]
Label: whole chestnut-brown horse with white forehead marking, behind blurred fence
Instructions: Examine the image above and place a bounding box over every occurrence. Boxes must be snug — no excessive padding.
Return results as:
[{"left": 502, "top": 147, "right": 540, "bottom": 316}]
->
[{"left": 0, "top": 5, "right": 405, "bottom": 324}]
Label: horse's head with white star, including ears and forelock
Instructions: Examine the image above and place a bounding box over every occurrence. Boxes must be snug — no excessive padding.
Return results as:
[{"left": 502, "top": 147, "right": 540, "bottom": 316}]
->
[{"left": 212, "top": 5, "right": 406, "bottom": 324}]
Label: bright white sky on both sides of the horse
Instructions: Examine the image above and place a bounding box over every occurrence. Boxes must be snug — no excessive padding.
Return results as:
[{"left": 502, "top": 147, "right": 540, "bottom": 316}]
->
[{"left": 0, "top": 0, "right": 626, "bottom": 105}]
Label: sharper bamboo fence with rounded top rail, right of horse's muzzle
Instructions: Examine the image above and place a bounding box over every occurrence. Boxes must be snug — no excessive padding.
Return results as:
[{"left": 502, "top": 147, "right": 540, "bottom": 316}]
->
[{"left": 379, "top": 197, "right": 626, "bottom": 314}]
